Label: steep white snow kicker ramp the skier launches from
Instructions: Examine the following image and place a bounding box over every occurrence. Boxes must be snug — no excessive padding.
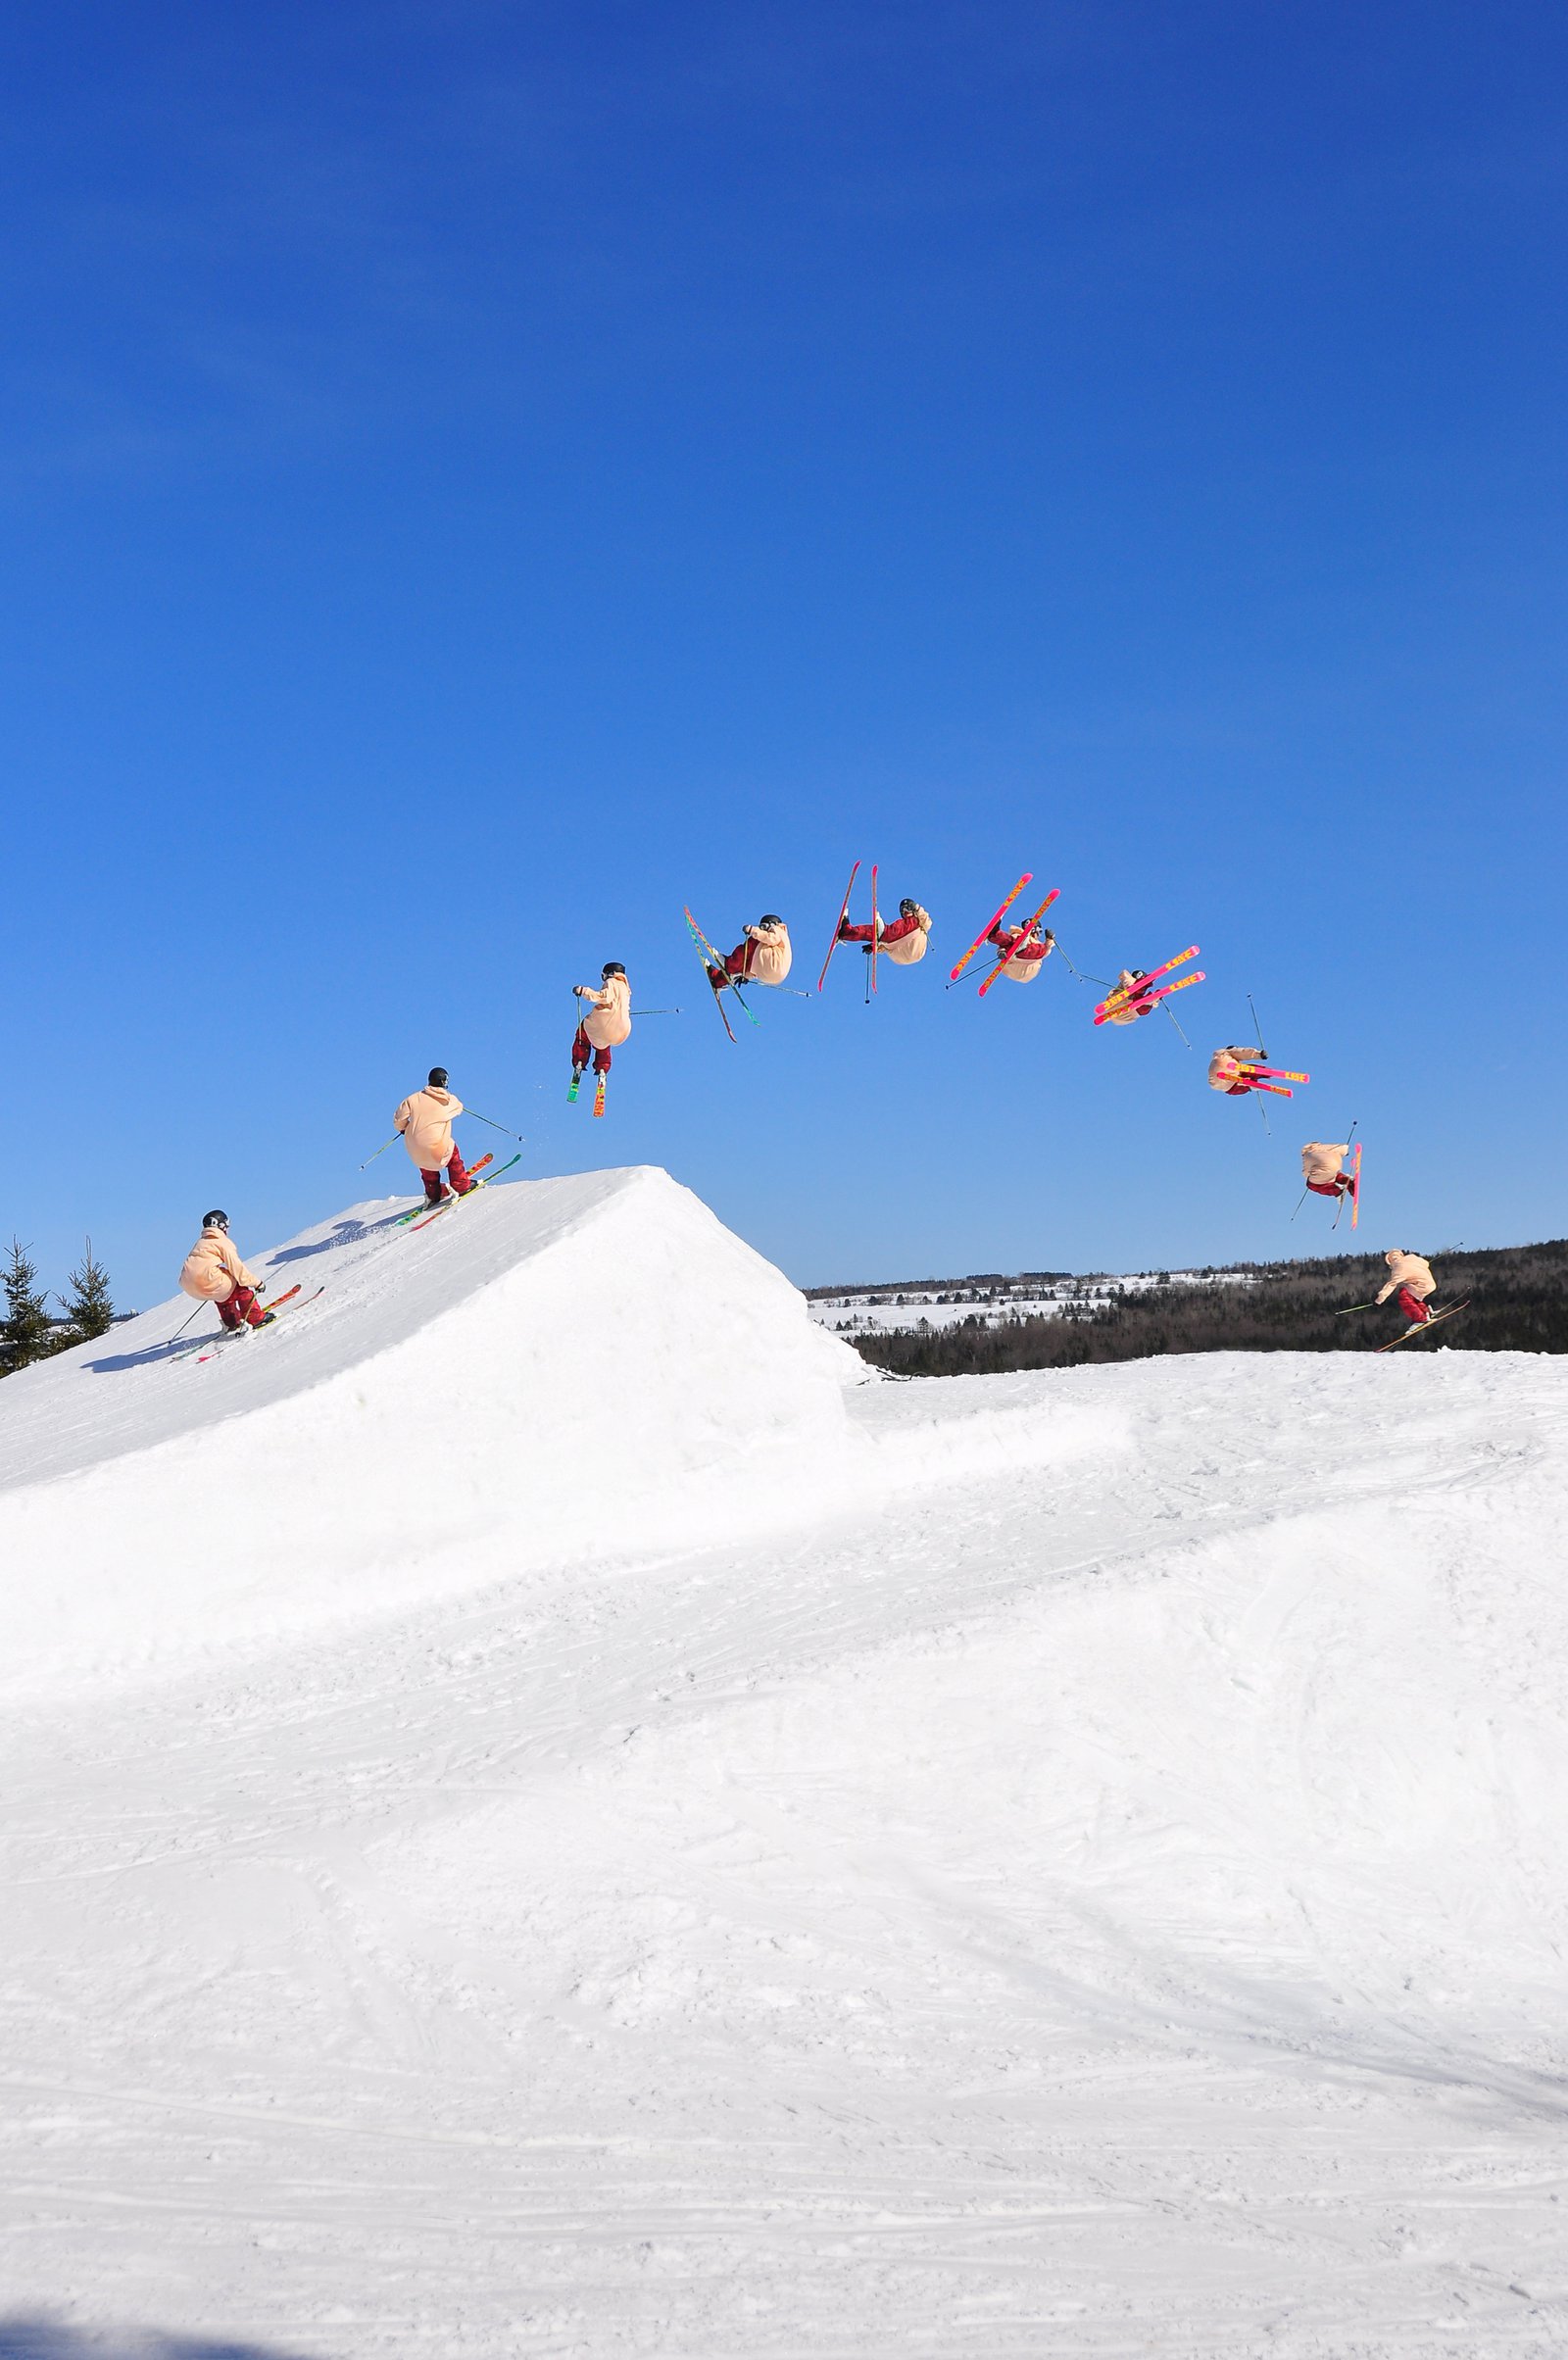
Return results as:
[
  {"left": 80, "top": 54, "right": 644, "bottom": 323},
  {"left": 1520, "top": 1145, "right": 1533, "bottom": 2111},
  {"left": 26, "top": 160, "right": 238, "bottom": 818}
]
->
[{"left": 0, "top": 1166, "right": 1105, "bottom": 1695}]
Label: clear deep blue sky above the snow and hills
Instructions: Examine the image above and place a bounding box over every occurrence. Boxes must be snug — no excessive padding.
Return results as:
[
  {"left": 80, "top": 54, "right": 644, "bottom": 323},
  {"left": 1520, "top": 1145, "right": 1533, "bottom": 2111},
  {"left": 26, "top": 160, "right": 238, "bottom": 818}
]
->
[{"left": 0, "top": 0, "right": 1568, "bottom": 1303}]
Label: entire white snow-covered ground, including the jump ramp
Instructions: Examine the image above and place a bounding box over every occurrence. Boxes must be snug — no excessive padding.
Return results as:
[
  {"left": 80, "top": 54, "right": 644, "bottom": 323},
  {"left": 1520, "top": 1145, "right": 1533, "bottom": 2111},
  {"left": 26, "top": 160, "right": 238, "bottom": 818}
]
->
[{"left": 0, "top": 1170, "right": 1568, "bottom": 2360}]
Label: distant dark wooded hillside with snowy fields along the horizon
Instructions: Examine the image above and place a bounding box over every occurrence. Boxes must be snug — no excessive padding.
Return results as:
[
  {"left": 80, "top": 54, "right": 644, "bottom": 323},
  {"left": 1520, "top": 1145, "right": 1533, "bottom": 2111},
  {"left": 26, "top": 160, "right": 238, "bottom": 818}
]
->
[{"left": 843, "top": 1239, "right": 1568, "bottom": 1376}]
